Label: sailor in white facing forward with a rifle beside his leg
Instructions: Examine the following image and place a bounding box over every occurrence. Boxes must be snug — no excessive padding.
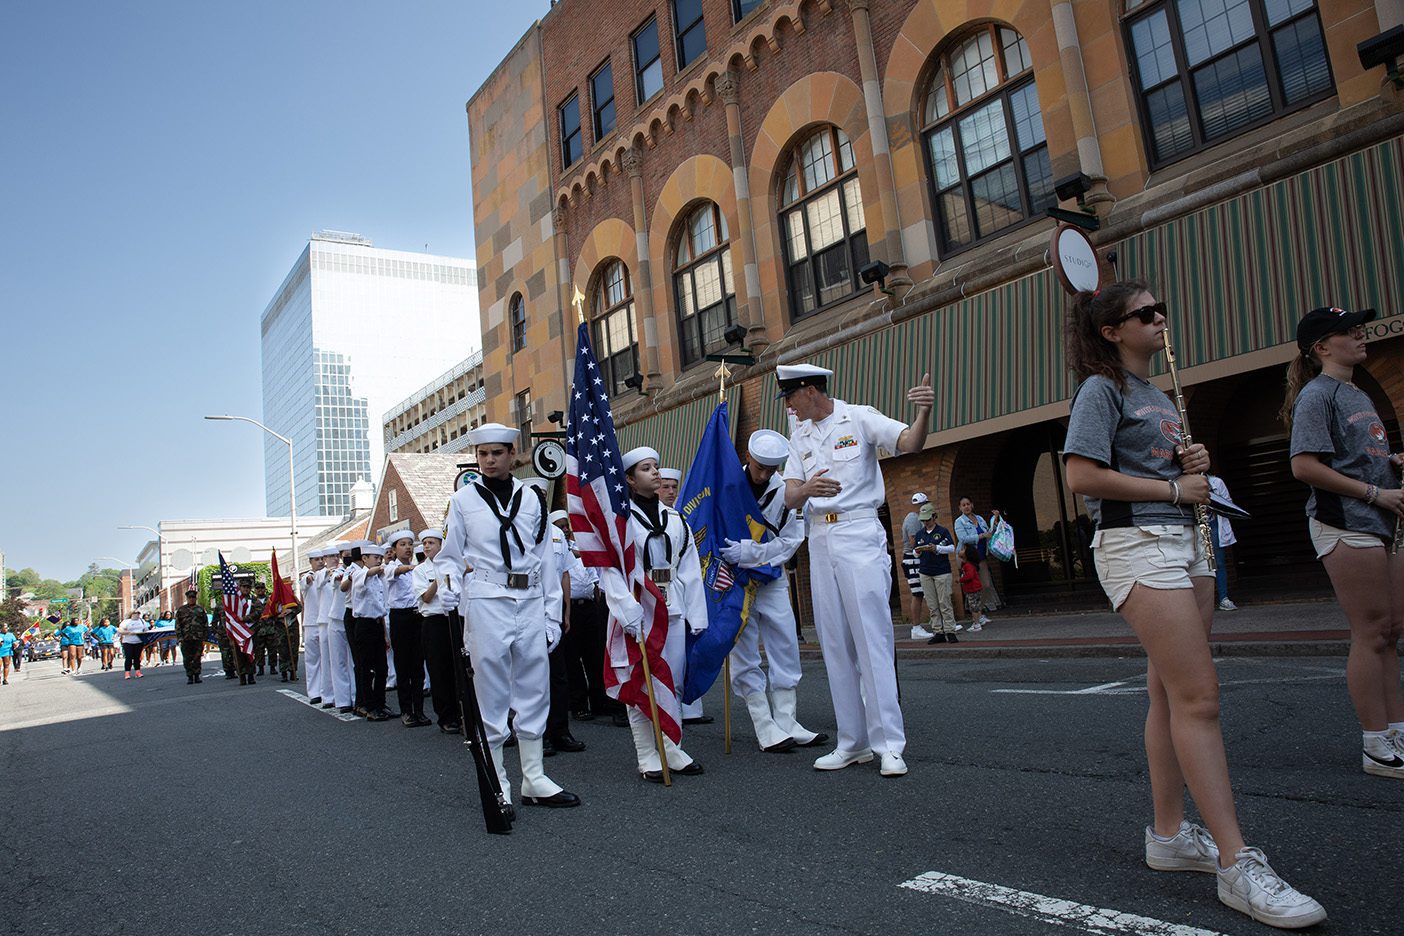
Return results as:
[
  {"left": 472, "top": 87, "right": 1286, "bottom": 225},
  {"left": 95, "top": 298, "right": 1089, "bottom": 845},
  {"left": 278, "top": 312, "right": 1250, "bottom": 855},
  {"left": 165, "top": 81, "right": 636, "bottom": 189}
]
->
[{"left": 439, "top": 422, "right": 580, "bottom": 807}]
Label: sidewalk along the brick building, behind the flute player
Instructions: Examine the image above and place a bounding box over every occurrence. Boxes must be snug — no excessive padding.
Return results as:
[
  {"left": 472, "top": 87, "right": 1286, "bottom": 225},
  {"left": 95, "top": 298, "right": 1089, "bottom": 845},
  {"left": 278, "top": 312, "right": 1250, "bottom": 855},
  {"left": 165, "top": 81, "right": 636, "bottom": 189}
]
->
[{"left": 800, "top": 601, "right": 1351, "bottom": 660}]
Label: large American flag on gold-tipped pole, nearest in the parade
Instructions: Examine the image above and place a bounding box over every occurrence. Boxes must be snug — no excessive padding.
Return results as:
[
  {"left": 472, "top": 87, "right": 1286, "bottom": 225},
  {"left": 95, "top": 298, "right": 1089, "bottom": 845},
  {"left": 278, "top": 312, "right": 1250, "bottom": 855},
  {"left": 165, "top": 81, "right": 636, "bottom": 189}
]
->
[{"left": 566, "top": 323, "right": 682, "bottom": 742}]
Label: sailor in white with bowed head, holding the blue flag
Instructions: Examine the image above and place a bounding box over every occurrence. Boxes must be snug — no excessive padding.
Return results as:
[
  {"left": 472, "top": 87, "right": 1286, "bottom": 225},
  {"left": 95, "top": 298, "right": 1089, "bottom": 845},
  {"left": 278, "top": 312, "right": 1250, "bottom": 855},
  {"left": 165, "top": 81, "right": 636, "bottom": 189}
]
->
[{"left": 722, "top": 429, "right": 828, "bottom": 752}]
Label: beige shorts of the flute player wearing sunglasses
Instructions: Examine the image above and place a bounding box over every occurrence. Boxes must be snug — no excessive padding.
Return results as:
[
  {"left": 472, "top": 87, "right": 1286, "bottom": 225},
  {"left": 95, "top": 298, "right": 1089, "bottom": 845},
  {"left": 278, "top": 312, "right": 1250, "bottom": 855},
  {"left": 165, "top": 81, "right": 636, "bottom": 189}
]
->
[{"left": 1092, "top": 526, "right": 1213, "bottom": 610}]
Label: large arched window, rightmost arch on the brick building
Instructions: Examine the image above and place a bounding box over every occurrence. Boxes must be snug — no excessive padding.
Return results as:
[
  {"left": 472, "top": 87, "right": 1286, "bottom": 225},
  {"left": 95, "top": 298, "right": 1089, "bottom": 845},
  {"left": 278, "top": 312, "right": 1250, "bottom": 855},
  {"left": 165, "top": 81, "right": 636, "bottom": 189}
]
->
[{"left": 922, "top": 24, "right": 1057, "bottom": 253}]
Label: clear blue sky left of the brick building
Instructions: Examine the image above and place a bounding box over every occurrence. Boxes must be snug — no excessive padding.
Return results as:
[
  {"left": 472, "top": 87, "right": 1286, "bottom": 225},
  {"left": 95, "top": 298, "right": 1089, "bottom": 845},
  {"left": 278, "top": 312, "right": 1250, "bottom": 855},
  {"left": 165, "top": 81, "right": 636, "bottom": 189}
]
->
[{"left": 0, "top": 0, "right": 549, "bottom": 578}]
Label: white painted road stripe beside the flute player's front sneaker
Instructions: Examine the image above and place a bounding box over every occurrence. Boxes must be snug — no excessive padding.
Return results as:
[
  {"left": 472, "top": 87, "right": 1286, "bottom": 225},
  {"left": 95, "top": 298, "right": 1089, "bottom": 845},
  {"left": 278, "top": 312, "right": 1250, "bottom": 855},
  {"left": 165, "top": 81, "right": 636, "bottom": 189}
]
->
[{"left": 897, "top": 871, "right": 1221, "bottom": 936}]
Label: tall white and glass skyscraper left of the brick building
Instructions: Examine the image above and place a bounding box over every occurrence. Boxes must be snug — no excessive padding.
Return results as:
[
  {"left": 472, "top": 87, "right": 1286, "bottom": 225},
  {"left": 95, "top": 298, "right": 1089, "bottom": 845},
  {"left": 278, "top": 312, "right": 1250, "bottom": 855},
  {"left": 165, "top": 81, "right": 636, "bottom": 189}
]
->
[{"left": 263, "top": 232, "right": 482, "bottom": 516}]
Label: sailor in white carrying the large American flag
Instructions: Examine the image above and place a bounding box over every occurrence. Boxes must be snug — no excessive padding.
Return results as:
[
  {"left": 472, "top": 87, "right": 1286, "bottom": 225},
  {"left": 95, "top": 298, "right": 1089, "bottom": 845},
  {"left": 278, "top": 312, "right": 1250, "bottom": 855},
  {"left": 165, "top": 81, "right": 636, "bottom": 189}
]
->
[{"left": 600, "top": 446, "right": 708, "bottom": 783}]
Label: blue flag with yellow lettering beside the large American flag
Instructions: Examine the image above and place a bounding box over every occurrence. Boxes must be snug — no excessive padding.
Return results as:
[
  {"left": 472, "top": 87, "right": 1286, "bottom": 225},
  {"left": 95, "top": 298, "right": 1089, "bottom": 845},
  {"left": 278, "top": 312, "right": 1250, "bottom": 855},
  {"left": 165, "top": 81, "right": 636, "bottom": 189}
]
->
[{"left": 677, "top": 403, "right": 779, "bottom": 702}]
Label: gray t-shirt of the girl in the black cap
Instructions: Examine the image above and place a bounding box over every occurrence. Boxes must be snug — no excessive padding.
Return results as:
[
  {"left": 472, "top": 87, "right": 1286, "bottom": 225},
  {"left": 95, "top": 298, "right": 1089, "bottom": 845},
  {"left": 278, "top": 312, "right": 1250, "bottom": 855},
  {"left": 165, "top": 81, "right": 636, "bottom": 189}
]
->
[{"left": 1292, "top": 373, "right": 1400, "bottom": 539}]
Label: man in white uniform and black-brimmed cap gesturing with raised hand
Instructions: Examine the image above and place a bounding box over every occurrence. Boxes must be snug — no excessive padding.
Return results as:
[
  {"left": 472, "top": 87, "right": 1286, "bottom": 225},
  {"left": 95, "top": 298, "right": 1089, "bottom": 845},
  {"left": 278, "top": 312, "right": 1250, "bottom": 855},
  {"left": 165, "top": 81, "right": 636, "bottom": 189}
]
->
[{"left": 775, "top": 363, "right": 935, "bottom": 777}]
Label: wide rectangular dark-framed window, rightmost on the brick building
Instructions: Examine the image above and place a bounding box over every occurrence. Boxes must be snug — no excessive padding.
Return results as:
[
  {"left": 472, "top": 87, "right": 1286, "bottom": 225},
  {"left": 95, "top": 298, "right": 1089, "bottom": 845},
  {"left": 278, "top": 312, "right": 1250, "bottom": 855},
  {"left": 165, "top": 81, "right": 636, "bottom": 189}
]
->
[{"left": 1126, "top": 0, "right": 1334, "bottom": 166}]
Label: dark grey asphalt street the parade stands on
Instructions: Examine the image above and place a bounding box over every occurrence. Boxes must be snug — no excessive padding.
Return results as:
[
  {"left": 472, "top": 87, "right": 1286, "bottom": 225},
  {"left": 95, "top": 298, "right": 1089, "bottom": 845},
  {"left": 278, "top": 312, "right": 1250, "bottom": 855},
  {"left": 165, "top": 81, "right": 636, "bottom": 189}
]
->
[{"left": 0, "top": 657, "right": 1404, "bottom": 936}]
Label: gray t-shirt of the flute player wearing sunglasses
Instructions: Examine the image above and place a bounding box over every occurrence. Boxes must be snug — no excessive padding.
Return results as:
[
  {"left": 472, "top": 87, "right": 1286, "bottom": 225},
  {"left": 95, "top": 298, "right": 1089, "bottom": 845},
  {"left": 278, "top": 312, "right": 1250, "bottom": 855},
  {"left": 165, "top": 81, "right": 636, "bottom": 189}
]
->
[{"left": 1063, "top": 370, "right": 1193, "bottom": 529}]
